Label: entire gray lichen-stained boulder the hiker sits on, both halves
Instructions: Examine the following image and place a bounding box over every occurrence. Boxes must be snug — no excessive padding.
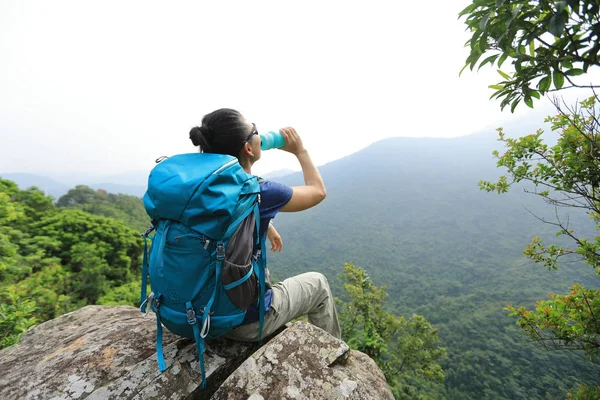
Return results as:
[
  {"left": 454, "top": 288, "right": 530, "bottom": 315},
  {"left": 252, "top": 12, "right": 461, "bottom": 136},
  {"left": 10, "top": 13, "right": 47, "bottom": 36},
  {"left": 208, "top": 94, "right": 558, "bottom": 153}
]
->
[{"left": 0, "top": 306, "right": 392, "bottom": 400}]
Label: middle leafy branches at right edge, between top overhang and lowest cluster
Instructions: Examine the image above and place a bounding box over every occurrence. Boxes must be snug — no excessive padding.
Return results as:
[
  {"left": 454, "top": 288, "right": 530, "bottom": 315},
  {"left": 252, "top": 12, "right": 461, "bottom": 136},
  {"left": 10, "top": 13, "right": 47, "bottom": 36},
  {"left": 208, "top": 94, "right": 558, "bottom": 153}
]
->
[{"left": 479, "top": 98, "right": 600, "bottom": 273}]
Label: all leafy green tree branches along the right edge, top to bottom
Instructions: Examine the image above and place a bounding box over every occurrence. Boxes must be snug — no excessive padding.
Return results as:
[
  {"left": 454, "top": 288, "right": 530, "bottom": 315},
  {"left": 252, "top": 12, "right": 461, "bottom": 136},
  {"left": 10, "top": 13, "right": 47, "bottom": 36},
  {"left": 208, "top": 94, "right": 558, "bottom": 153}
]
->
[{"left": 459, "top": 0, "right": 600, "bottom": 398}]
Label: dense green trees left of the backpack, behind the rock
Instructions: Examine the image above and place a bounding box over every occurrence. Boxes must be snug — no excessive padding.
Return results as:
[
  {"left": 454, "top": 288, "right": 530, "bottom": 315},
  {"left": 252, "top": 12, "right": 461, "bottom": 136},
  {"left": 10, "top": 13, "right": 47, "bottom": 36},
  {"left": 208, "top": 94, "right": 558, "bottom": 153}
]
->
[{"left": 0, "top": 179, "right": 147, "bottom": 346}]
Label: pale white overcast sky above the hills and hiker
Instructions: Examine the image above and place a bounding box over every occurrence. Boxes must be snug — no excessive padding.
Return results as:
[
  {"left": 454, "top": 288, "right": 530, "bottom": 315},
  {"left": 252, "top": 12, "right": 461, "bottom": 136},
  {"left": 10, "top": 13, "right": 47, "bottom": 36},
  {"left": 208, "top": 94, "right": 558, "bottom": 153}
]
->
[{"left": 0, "top": 0, "right": 576, "bottom": 175}]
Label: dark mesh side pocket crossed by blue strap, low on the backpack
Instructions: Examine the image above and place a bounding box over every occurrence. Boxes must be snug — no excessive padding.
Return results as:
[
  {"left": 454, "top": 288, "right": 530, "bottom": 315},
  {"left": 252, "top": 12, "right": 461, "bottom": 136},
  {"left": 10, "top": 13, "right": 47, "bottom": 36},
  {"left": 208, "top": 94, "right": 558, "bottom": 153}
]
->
[{"left": 221, "top": 261, "right": 258, "bottom": 310}]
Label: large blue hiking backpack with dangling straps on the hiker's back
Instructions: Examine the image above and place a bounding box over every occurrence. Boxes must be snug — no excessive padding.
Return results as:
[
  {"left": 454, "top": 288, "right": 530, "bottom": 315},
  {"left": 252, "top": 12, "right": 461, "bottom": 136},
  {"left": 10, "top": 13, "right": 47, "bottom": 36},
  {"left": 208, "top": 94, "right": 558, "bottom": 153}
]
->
[{"left": 140, "top": 153, "right": 266, "bottom": 388}]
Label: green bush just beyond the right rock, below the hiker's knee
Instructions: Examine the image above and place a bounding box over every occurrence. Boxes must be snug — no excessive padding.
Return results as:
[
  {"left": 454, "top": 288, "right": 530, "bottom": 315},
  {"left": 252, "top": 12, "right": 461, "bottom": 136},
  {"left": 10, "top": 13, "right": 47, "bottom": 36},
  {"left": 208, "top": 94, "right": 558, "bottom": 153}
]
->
[{"left": 340, "top": 264, "right": 446, "bottom": 398}]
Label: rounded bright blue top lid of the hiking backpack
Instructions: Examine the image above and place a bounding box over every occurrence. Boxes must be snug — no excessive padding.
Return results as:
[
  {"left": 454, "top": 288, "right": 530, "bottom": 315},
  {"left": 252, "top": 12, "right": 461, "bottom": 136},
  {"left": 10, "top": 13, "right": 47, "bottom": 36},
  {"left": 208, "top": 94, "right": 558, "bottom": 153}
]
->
[{"left": 144, "top": 153, "right": 260, "bottom": 239}]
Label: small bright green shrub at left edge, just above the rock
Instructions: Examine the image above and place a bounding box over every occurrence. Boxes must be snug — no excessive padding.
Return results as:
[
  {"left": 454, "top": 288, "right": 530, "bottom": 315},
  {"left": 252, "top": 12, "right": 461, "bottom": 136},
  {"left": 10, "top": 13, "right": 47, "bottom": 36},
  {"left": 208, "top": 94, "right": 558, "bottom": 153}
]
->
[{"left": 0, "top": 290, "right": 37, "bottom": 349}]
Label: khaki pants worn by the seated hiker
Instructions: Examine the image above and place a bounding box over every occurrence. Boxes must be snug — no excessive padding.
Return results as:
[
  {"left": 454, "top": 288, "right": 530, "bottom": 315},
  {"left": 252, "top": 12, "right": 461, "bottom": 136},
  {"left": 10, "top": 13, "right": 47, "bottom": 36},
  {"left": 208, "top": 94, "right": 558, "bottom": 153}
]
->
[{"left": 226, "top": 272, "right": 341, "bottom": 342}]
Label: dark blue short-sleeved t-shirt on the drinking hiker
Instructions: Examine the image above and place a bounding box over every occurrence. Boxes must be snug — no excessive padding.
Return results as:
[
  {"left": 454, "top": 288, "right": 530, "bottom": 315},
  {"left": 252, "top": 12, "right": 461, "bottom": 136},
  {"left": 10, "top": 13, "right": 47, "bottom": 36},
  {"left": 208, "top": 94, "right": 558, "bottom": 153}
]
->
[{"left": 242, "top": 181, "right": 293, "bottom": 325}]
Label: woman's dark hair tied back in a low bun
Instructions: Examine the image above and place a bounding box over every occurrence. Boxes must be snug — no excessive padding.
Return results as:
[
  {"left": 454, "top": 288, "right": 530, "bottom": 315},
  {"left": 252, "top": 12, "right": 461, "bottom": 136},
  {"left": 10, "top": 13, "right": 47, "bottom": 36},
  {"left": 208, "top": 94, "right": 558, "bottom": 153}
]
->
[{"left": 190, "top": 108, "right": 249, "bottom": 157}]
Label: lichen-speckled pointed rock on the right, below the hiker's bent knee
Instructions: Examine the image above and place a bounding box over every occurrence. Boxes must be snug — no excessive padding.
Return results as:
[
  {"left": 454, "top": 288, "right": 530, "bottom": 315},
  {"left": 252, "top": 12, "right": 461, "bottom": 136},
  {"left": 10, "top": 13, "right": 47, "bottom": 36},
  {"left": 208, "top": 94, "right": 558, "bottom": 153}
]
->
[{"left": 211, "top": 322, "right": 394, "bottom": 400}]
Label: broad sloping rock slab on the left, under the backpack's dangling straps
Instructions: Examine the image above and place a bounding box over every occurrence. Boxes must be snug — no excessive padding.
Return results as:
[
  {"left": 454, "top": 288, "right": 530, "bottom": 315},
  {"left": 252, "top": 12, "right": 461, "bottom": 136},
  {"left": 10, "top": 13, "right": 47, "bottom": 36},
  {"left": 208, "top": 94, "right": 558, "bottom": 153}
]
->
[{"left": 0, "top": 306, "right": 255, "bottom": 400}]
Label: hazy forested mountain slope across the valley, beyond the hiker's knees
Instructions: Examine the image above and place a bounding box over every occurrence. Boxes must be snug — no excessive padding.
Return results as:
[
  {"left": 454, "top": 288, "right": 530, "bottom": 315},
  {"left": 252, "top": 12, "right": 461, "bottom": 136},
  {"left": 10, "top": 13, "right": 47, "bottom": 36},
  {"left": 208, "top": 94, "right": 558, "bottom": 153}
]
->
[{"left": 269, "top": 132, "right": 600, "bottom": 399}]
